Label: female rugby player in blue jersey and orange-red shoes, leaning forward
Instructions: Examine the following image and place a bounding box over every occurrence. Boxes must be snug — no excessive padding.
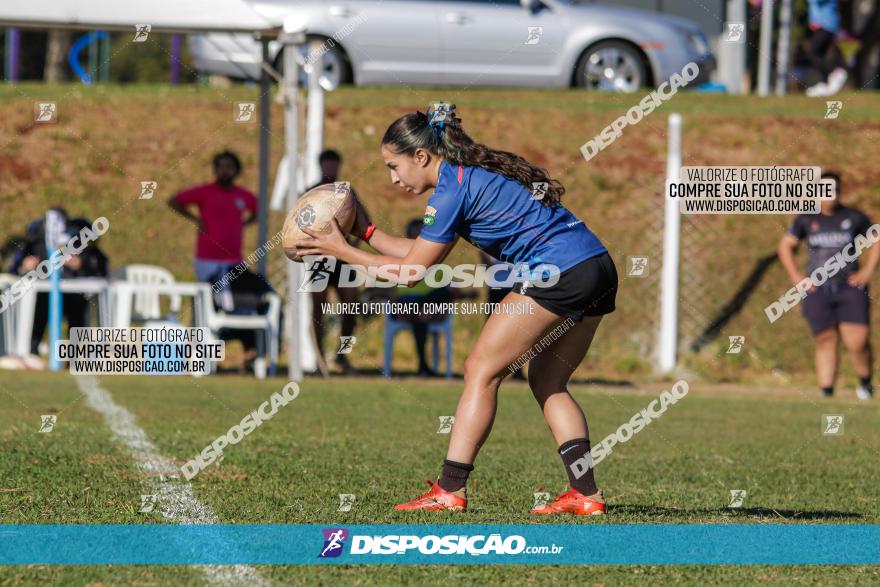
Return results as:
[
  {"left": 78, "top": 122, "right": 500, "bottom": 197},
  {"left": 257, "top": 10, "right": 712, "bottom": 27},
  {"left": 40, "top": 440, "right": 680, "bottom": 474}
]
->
[{"left": 294, "top": 104, "right": 617, "bottom": 514}]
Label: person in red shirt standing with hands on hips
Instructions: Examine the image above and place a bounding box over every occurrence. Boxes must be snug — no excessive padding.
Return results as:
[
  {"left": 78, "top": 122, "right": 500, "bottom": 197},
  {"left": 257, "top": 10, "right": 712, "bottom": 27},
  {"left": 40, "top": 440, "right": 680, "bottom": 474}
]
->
[{"left": 168, "top": 151, "right": 257, "bottom": 281}]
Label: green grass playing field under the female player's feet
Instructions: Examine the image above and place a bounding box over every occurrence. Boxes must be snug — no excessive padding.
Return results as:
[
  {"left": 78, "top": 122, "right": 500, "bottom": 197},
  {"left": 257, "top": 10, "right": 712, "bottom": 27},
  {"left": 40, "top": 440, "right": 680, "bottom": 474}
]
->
[{"left": 0, "top": 373, "right": 880, "bottom": 585}]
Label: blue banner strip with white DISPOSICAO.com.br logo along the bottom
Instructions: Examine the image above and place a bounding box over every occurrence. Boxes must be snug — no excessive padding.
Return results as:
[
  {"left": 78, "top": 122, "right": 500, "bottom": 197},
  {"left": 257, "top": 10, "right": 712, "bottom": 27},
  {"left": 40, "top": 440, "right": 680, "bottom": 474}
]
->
[{"left": 0, "top": 524, "right": 880, "bottom": 565}]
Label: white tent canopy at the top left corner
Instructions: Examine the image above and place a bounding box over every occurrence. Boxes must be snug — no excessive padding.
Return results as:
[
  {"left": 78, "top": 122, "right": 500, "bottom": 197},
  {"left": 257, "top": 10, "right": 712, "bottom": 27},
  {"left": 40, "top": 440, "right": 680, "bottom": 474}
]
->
[{"left": 0, "top": 0, "right": 280, "bottom": 33}]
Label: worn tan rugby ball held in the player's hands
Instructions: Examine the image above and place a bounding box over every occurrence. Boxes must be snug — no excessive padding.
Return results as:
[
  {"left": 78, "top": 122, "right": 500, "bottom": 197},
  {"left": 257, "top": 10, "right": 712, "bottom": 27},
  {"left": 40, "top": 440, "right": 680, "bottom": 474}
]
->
[{"left": 281, "top": 181, "right": 356, "bottom": 263}]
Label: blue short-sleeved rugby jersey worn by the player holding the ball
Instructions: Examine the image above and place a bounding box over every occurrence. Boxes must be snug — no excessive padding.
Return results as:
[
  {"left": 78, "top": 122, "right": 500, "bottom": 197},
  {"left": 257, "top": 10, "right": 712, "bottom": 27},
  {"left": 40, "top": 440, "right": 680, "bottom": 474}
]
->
[{"left": 420, "top": 160, "right": 607, "bottom": 271}]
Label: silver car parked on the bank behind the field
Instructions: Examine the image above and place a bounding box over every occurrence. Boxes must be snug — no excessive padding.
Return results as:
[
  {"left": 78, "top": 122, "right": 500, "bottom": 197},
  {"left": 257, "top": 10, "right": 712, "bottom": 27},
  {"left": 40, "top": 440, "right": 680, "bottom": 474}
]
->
[{"left": 190, "top": 0, "right": 715, "bottom": 92}]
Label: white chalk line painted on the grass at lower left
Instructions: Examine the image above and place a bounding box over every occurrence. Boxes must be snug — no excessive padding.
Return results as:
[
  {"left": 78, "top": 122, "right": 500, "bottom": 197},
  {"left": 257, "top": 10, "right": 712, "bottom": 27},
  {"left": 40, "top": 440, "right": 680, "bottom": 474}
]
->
[{"left": 74, "top": 375, "right": 266, "bottom": 585}]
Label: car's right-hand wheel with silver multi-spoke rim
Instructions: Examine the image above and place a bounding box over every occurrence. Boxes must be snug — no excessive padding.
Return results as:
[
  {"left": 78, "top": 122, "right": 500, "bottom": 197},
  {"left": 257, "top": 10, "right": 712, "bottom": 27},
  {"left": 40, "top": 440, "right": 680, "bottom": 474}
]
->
[{"left": 575, "top": 41, "right": 648, "bottom": 94}]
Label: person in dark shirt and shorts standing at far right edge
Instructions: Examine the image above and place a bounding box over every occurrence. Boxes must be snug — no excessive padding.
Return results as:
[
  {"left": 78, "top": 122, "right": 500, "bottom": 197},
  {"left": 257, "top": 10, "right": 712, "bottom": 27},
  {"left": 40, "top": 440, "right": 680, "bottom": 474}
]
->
[{"left": 778, "top": 172, "right": 880, "bottom": 400}]
